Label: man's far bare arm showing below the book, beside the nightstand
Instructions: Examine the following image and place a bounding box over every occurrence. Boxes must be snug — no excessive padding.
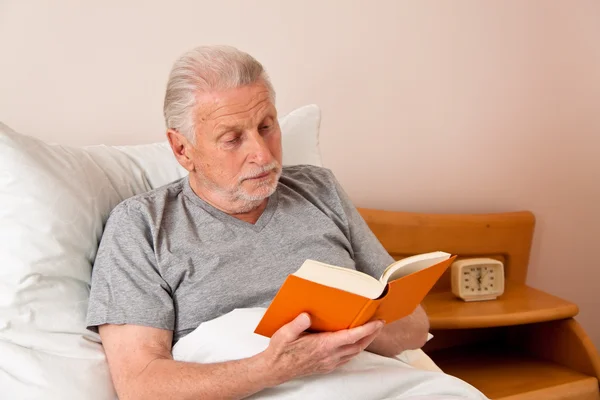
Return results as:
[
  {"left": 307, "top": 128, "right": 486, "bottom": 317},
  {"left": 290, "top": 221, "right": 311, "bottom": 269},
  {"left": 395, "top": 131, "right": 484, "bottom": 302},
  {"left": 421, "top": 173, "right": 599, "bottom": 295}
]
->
[{"left": 367, "top": 305, "right": 429, "bottom": 357}]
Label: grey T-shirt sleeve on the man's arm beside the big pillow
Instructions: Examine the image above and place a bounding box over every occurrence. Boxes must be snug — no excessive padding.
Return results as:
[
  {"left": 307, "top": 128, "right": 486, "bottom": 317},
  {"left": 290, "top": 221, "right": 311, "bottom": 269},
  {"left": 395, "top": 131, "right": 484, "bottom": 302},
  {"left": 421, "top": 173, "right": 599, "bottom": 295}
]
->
[{"left": 87, "top": 201, "right": 175, "bottom": 332}]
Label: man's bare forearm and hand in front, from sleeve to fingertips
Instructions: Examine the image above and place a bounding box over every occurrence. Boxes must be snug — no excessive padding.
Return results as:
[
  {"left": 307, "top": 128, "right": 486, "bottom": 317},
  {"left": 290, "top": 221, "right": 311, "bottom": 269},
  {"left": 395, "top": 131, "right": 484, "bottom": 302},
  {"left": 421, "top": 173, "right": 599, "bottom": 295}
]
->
[{"left": 99, "top": 314, "right": 383, "bottom": 400}]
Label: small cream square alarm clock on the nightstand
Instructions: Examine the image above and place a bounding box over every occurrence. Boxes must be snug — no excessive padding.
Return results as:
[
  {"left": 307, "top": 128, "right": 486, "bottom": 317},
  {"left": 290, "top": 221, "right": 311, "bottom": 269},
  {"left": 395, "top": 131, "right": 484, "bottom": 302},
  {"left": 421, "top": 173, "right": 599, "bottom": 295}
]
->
[{"left": 450, "top": 258, "right": 504, "bottom": 301}]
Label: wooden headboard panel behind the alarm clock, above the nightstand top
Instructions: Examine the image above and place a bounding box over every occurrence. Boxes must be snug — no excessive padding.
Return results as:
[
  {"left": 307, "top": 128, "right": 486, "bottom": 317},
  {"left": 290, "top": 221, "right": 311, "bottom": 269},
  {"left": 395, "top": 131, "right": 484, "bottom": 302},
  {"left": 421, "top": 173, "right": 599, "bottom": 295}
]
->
[{"left": 358, "top": 208, "right": 535, "bottom": 291}]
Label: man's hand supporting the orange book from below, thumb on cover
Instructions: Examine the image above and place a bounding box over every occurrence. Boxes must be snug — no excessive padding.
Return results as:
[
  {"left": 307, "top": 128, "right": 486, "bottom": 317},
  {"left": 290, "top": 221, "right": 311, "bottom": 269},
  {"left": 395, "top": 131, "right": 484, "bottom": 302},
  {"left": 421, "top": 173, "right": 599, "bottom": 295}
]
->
[{"left": 261, "top": 313, "right": 384, "bottom": 385}]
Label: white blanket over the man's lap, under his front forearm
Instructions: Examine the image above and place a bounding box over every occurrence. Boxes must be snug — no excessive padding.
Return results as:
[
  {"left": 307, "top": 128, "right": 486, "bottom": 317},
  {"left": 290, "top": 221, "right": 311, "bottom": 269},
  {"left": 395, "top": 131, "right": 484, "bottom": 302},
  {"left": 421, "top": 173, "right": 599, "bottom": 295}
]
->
[{"left": 173, "top": 308, "right": 487, "bottom": 400}]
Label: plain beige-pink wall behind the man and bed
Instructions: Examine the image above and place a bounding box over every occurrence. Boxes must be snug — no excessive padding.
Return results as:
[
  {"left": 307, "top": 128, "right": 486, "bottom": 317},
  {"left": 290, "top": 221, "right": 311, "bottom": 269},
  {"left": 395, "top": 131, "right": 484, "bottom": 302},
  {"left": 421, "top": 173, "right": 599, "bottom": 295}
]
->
[{"left": 0, "top": 0, "right": 600, "bottom": 346}]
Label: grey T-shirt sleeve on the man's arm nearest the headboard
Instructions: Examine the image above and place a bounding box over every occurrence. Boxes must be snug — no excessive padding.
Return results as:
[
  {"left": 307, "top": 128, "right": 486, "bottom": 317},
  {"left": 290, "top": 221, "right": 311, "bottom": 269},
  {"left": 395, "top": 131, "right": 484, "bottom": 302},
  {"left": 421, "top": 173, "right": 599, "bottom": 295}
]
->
[{"left": 333, "top": 177, "right": 394, "bottom": 279}]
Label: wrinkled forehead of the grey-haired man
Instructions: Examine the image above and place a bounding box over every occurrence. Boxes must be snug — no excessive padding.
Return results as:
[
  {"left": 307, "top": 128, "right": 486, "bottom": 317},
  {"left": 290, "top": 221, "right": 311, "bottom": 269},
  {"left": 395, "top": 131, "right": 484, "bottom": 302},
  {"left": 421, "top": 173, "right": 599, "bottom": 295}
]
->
[{"left": 196, "top": 83, "right": 275, "bottom": 126}]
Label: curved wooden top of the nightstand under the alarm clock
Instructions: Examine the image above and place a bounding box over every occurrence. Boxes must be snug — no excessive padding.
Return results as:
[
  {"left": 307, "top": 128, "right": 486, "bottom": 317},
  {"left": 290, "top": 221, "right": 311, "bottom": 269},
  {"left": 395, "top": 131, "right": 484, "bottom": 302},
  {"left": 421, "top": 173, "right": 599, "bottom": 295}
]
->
[{"left": 423, "top": 282, "right": 579, "bottom": 329}]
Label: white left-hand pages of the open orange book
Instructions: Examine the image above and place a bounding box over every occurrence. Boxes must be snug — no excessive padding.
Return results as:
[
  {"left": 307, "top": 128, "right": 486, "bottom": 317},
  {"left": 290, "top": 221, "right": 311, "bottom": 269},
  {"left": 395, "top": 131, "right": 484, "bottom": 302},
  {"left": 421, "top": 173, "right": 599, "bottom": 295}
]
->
[{"left": 293, "top": 260, "right": 385, "bottom": 299}]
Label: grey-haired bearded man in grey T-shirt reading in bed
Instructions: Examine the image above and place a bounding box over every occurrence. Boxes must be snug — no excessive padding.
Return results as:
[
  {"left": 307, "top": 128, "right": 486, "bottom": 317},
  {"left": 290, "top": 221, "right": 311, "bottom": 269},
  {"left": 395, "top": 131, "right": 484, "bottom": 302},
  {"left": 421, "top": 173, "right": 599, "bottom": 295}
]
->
[{"left": 88, "top": 47, "right": 486, "bottom": 399}]
